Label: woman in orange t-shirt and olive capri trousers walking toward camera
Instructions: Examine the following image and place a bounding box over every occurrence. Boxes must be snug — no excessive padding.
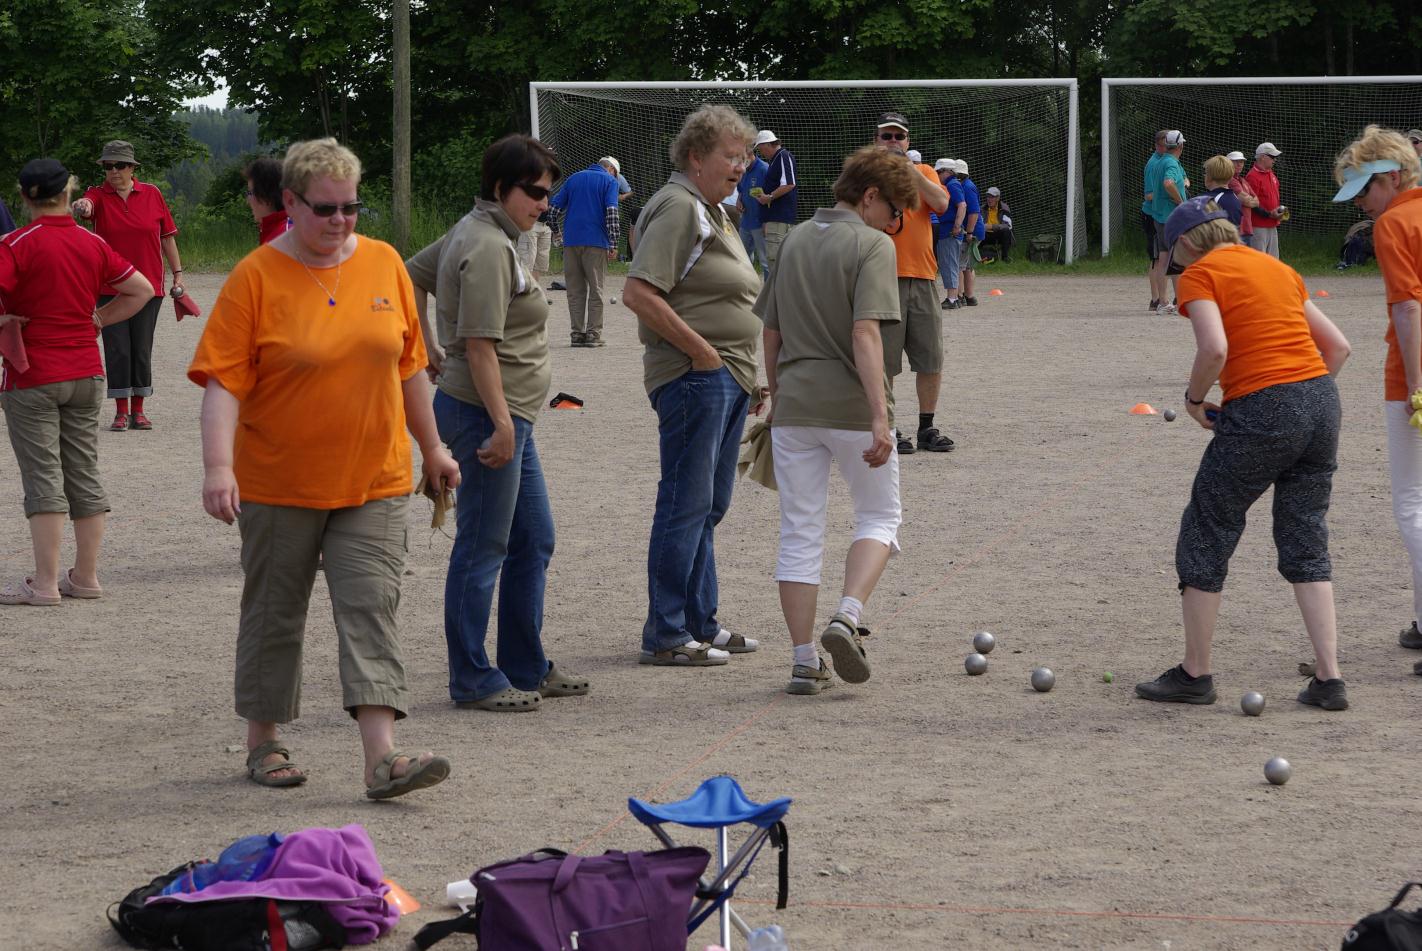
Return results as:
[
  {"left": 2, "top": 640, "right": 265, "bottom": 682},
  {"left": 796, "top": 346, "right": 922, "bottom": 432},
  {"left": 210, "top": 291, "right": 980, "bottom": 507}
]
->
[{"left": 188, "top": 139, "right": 459, "bottom": 799}]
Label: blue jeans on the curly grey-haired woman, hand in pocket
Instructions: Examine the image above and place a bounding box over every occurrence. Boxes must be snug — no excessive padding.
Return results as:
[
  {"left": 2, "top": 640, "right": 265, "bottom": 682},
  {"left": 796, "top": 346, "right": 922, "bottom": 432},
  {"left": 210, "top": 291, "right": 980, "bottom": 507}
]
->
[{"left": 641, "top": 367, "right": 751, "bottom": 651}]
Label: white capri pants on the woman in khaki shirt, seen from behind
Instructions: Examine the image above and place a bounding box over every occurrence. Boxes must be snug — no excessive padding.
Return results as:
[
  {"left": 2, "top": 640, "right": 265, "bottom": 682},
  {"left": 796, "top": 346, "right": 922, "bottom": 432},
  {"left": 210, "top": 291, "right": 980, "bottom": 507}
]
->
[{"left": 771, "top": 426, "right": 903, "bottom": 584}]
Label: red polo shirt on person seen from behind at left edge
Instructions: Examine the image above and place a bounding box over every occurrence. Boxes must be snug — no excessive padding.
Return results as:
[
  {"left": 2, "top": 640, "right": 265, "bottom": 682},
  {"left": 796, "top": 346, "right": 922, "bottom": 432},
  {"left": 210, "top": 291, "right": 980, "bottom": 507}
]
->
[{"left": 0, "top": 215, "right": 134, "bottom": 389}]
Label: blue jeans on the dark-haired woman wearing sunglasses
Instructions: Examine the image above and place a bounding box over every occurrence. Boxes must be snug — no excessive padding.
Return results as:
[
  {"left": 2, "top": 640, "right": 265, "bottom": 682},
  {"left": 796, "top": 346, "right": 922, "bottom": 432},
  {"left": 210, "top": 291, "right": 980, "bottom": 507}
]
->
[{"left": 435, "top": 389, "right": 553, "bottom": 702}]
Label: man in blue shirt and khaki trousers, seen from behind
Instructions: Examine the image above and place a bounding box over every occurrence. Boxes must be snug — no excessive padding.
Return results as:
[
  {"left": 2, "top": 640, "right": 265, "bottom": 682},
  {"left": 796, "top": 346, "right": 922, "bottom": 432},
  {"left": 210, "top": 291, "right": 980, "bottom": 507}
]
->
[{"left": 549, "top": 163, "right": 621, "bottom": 347}]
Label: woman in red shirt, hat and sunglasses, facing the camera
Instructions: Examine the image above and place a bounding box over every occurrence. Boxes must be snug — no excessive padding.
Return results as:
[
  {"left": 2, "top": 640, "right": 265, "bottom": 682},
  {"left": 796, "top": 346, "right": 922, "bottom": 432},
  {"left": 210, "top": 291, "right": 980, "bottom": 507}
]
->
[{"left": 74, "top": 139, "right": 183, "bottom": 432}]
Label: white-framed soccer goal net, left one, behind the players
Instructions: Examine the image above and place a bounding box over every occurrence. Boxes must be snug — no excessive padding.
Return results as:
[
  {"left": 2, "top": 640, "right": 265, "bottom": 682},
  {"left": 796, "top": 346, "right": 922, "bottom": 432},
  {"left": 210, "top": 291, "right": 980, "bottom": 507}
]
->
[{"left": 529, "top": 80, "right": 1086, "bottom": 262}]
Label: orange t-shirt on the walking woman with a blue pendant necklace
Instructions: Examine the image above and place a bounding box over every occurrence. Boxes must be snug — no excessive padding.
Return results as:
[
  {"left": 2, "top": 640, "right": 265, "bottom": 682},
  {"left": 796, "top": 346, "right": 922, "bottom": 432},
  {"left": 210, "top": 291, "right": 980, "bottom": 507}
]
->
[{"left": 188, "top": 236, "right": 427, "bottom": 509}]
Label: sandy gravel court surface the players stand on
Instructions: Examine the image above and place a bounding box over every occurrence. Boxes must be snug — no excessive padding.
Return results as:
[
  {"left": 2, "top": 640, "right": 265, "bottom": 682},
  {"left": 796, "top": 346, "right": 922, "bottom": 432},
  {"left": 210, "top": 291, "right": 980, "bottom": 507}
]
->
[{"left": 0, "top": 270, "right": 1422, "bottom": 951}]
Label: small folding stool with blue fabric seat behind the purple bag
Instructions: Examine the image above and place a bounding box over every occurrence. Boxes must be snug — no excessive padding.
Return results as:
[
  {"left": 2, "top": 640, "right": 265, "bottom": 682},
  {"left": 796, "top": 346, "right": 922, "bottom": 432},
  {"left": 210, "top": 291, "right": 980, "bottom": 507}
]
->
[{"left": 627, "top": 776, "right": 792, "bottom": 951}]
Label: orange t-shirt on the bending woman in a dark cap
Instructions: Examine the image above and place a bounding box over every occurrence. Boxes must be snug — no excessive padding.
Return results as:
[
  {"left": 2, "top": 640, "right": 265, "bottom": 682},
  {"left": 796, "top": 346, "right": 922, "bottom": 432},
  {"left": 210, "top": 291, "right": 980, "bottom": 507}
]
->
[{"left": 1177, "top": 245, "right": 1328, "bottom": 402}]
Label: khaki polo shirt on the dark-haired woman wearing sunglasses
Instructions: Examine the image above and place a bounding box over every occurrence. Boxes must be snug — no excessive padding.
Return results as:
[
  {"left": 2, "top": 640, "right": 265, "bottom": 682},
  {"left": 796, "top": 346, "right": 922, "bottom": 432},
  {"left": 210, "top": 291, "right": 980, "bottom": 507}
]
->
[{"left": 405, "top": 199, "right": 553, "bottom": 422}]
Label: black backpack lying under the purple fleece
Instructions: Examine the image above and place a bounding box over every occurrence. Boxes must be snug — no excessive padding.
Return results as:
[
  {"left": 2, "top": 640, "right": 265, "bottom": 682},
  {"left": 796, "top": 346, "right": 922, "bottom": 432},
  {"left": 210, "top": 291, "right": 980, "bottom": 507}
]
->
[{"left": 108, "top": 861, "right": 346, "bottom": 951}]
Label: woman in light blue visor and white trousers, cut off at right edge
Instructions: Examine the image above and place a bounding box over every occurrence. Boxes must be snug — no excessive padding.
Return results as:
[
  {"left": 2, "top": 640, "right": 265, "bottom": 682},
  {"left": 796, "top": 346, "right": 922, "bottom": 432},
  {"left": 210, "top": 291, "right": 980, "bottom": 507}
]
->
[{"left": 1334, "top": 125, "right": 1422, "bottom": 675}]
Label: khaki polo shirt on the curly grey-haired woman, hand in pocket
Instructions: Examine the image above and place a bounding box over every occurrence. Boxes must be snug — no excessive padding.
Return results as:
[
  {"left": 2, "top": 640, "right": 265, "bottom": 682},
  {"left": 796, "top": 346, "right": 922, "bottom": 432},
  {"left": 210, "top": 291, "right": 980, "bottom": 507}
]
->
[{"left": 627, "top": 172, "right": 761, "bottom": 394}]
